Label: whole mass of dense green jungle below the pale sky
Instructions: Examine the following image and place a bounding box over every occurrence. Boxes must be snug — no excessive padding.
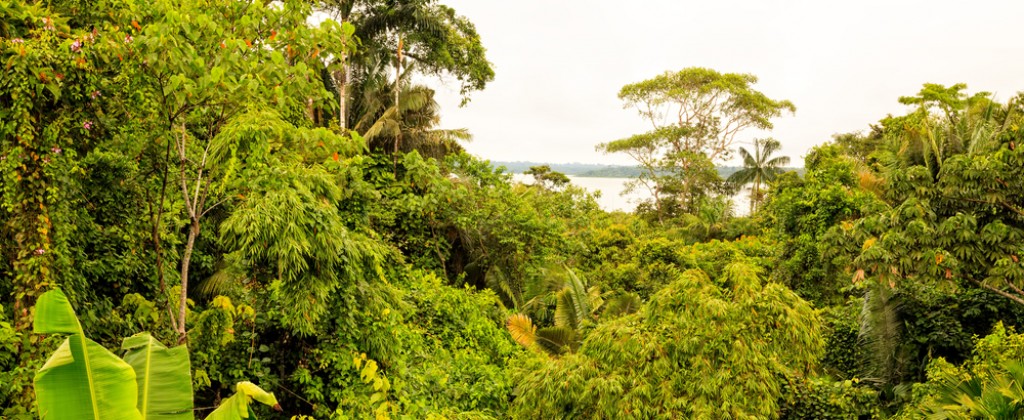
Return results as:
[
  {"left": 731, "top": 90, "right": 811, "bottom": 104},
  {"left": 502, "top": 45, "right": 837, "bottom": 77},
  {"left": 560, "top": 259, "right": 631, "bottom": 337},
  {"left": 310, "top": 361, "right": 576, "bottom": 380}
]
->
[{"left": 0, "top": 0, "right": 1024, "bottom": 419}]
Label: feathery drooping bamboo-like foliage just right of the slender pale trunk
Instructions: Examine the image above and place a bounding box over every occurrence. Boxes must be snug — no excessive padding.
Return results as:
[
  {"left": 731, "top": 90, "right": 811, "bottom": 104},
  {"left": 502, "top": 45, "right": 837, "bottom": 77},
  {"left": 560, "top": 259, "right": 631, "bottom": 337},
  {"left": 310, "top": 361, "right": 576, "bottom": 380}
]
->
[{"left": 220, "top": 120, "right": 386, "bottom": 334}]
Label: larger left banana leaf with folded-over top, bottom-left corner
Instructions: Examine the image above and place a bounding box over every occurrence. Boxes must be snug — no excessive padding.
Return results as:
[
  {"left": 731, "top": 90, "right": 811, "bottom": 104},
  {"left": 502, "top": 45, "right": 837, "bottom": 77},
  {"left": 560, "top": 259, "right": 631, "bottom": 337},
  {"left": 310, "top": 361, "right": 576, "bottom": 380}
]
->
[{"left": 34, "top": 290, "right": 141, "bottom": 420}]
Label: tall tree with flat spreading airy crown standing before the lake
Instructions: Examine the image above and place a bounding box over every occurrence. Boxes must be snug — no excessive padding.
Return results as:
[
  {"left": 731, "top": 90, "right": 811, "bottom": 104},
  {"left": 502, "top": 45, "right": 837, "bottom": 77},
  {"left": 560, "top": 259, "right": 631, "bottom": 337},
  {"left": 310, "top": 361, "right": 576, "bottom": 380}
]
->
[{"left": 597, "top": 68, "right": 796, "bottom": 218}]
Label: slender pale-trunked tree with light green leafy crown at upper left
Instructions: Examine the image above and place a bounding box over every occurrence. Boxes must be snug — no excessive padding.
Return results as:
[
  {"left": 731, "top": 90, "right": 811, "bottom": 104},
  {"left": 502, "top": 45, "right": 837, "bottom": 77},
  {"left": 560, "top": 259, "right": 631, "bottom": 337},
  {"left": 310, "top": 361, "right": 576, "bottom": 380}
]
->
[{"left": 124, "top": 0, "right": 352, "bottom": 341}]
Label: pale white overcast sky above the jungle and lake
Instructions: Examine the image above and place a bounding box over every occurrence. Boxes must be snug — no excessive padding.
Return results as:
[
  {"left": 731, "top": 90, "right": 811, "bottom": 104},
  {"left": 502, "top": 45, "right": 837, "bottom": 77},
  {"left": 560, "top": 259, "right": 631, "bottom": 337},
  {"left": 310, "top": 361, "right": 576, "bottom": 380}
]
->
[{"left": 428, "top": 0, "right": 1024, "bottom": 164}]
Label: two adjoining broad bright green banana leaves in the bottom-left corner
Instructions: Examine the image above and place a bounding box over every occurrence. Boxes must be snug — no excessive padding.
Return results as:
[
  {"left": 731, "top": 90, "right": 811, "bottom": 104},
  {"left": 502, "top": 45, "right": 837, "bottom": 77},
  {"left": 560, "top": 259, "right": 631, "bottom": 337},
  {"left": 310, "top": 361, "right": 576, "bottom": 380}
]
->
[{"left": 35, "top": 289, "right": 193, "bottom": 420}]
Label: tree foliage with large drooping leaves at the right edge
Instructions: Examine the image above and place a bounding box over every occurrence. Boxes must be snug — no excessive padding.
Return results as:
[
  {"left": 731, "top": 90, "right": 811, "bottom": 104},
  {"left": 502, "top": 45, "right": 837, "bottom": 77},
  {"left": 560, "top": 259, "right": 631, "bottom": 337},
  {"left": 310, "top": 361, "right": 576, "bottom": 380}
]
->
[{"left": 833, "top": 124, "right": 1024, "bottom": 303}]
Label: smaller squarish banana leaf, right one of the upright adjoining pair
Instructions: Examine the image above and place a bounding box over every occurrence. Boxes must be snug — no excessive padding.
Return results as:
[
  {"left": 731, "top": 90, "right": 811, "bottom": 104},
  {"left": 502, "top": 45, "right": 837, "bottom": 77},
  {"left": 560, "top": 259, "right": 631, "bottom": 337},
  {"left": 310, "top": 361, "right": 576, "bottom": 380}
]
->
[{"left": 121, "top": 333, "right": 194, "bottom": 420}]
